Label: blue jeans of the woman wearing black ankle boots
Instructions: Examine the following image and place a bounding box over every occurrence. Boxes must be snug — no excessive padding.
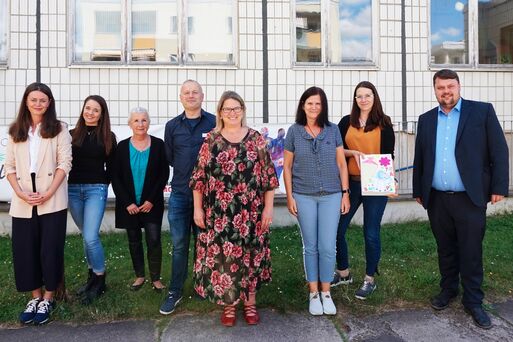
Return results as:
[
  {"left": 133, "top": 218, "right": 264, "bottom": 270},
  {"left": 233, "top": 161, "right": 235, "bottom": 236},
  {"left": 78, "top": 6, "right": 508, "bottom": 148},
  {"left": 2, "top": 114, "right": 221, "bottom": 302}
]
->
[{"left": 68, "top": 184, "right": 108, "bottom": 273}]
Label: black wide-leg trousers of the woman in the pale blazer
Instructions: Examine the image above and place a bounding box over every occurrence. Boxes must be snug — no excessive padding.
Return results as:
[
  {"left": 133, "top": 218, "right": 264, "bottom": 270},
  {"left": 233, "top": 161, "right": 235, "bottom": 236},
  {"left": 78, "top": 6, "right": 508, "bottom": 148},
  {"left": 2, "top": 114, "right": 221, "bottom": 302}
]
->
[{"left": 12, "top": 207, "right": 67, "bottom": 292}]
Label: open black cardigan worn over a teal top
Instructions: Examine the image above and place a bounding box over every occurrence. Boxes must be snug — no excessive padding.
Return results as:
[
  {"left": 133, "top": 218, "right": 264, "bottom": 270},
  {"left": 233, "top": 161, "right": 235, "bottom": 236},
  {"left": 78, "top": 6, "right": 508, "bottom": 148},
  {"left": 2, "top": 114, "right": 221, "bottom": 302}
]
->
[{"left": 112, "top": 135, "right": 169, "bottom": 228}]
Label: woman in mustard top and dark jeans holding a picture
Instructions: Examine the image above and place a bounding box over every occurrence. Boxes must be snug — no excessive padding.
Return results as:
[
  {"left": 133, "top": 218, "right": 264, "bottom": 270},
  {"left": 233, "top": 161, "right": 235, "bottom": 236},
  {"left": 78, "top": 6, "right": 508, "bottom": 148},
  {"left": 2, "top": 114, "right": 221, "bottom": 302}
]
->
[{"left": 331, "top": 81, "right": 395, "bottom": 300}]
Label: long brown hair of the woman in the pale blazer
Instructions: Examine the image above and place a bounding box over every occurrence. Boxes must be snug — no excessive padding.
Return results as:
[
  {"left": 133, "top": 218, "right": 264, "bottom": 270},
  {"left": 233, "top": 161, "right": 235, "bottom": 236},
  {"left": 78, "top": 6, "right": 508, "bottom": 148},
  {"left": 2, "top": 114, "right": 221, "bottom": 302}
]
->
[{"left": 9, "top": 82, "right": 62, "bottom": 143}]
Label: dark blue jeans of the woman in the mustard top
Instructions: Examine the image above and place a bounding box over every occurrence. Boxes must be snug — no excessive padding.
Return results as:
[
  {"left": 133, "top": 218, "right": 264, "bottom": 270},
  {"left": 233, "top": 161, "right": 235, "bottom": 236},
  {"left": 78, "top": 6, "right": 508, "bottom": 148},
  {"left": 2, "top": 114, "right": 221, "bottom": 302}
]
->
[{"left": 337, "top": 180, "right": 388, "bottom": 277}]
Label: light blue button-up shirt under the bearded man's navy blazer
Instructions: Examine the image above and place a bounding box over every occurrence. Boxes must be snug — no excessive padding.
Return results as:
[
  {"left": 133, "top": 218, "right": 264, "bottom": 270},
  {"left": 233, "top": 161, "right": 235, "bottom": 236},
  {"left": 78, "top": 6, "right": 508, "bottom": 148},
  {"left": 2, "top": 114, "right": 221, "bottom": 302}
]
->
[{"left": 432, "top": 98, "right": 465, "bottom": 191}]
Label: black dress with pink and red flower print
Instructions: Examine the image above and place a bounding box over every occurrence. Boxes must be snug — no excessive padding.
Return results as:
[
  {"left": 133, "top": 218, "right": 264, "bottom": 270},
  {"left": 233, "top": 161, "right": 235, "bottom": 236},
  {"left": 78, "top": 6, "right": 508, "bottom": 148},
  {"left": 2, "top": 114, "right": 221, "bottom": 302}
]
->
[{"left": 190, "top": 128, "right": 278, "bottom": 305}]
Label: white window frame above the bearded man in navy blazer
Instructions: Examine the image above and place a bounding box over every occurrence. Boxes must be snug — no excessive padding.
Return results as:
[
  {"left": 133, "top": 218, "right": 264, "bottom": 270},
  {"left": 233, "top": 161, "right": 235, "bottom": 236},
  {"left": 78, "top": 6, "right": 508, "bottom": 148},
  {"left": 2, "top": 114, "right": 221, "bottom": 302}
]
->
[{"left": 427, "top": 0, "right": 513, "bottom": 71}]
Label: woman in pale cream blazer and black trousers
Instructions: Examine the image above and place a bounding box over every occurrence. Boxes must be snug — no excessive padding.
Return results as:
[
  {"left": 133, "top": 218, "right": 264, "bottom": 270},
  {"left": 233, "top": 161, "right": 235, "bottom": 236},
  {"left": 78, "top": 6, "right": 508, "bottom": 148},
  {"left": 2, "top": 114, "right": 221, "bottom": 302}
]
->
[{"left": 5, "top": 83, "right": 72, "bottom": 324}]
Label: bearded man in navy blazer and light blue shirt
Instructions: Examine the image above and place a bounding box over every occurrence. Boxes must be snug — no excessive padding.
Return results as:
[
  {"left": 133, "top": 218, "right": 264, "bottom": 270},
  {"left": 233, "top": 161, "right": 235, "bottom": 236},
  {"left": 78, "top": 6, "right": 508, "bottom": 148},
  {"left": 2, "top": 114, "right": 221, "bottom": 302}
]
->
[{"left": 413, "top": 69, "right": 509, "bottom": 329}]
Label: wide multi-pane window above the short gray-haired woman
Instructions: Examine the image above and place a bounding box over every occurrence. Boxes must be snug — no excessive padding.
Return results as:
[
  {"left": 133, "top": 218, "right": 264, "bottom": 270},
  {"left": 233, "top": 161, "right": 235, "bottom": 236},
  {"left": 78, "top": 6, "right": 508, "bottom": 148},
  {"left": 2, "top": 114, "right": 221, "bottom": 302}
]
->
[{"left": 70, "top": 0, "right": 236, "bottom": 65}]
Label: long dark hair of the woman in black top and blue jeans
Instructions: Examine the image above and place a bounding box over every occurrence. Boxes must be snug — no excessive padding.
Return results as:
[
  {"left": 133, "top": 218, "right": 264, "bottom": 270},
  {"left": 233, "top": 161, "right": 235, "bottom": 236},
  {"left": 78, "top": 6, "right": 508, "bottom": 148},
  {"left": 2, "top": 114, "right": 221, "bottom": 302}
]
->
[{"left": 71, "top": 95, "right": 112, "bottom": 155}]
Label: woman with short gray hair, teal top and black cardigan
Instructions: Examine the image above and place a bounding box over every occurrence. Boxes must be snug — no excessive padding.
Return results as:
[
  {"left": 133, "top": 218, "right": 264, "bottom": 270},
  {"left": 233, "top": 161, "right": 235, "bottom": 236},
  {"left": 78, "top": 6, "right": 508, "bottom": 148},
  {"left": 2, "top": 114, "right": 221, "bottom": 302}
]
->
[{"left": 112, "top": 107, "right": 169, "bottom": 292}]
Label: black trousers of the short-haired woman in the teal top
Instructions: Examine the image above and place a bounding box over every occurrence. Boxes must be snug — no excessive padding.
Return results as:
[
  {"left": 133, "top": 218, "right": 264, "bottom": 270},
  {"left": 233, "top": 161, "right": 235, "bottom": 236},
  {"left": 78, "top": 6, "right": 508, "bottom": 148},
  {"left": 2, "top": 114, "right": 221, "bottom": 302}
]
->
[{"left": 126, "top": 222, "right": 162, "bottom": 281}]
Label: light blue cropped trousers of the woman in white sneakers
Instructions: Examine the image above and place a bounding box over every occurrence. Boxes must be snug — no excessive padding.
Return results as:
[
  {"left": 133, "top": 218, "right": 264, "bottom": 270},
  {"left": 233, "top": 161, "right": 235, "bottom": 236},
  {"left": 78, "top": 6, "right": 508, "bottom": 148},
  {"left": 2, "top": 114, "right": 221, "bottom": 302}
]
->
[{"left": 292, "top": 192, "right": 342, "bottom": 283}]
